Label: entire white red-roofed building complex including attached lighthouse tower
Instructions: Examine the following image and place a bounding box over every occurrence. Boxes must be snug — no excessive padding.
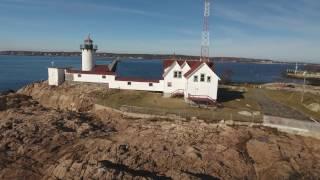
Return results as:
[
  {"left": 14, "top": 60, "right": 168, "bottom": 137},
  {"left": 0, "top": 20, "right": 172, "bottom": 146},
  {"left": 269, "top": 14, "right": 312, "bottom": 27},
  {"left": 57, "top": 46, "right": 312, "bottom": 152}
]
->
[{"left": 48, "top": 37, "right": 220, "bottom": 104}]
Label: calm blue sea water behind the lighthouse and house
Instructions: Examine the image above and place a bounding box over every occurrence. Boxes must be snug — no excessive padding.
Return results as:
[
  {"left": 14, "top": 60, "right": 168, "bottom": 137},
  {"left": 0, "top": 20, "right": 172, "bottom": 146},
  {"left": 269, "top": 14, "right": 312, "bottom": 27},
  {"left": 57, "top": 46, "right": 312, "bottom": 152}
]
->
[{"left": 0, "top": 56, "right": 300, "bottom": 91}]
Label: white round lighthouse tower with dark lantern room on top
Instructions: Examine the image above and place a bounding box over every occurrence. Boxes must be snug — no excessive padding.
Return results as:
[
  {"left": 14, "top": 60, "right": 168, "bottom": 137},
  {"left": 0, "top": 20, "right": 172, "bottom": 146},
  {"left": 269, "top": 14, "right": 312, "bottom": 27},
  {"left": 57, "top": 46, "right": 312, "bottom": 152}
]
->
[{"left": 80, "top": 35, "right": 98, "bottom": 71}]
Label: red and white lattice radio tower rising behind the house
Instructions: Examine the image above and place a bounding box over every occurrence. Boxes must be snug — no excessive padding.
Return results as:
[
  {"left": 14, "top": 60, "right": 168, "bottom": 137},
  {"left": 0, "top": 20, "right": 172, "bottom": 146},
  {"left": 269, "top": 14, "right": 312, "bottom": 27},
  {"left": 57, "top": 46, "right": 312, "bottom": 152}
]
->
[{"left": 200, "top": 0, "right": 210, "bottom": 62}]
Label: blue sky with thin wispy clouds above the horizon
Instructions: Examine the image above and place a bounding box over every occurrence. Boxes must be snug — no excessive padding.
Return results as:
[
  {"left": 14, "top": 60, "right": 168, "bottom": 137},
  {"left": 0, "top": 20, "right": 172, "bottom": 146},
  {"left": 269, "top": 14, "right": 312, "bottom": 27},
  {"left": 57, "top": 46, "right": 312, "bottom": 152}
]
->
[{"left": 0, "top": 0, "right": 320, "bottom": 63}]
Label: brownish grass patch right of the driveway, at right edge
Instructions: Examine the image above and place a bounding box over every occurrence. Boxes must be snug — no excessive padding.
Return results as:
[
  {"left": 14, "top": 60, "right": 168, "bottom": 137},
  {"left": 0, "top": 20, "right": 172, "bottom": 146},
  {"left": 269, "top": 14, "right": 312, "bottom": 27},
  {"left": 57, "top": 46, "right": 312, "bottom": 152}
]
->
[{"left": 265, "top": 90, "right": 320, "bottom": 120}]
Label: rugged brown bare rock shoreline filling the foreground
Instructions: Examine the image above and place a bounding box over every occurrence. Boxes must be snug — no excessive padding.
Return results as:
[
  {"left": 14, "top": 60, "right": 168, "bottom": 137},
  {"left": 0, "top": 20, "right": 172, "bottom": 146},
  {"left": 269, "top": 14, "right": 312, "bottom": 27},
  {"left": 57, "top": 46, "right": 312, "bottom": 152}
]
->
[{"left": 0, "top": 83, "right": 320, "bottom": 179}]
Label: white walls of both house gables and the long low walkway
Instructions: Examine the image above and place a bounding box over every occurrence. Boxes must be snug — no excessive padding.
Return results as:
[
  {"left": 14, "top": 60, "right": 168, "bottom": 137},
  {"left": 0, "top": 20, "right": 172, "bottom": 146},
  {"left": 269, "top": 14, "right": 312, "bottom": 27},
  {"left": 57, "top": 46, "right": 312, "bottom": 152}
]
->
[{"left": 67, "top": 63, "right": 219, "bottom": 100}]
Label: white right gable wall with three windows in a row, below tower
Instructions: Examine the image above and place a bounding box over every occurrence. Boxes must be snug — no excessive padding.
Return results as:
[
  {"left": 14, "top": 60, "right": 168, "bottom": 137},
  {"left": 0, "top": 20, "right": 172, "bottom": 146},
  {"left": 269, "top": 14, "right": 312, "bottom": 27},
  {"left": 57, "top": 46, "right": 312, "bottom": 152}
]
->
[{"left": 185, "top": 64, "right": 219, "bottom": 100}]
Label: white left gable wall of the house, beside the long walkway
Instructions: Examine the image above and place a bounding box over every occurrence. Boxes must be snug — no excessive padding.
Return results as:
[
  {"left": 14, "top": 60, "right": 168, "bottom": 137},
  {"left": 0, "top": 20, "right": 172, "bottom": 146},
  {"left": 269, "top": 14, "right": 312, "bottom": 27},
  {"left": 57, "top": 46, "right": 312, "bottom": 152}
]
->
[{"left": 164, "top": 62, "right": 186, "bottom": 94}]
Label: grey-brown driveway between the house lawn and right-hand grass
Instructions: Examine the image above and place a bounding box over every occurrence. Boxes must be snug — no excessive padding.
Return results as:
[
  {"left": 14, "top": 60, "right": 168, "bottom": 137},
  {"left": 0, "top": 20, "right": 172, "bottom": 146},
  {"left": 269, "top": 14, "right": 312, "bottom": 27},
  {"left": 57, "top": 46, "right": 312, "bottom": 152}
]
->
[{"left": 254, "top": 89, "right": 310, "bottom": 120}]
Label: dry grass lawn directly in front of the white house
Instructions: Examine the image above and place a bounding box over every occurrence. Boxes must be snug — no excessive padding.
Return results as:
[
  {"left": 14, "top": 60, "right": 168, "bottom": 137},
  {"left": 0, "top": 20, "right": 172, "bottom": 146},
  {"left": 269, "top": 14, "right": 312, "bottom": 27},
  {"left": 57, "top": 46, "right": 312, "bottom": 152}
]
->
[{"left": 92, "top": 89, "right": 262, "bottom": 122}]
